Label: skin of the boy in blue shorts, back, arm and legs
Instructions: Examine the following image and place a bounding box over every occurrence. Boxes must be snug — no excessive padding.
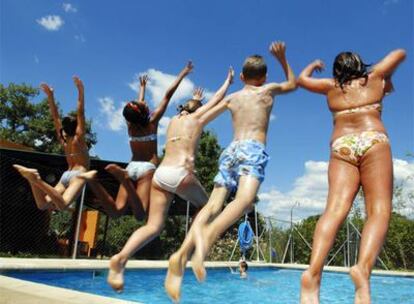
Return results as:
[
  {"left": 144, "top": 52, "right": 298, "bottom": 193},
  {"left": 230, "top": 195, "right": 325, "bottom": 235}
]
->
[{"left": 166, "top": 42, "right": 296, "bottom": 301}]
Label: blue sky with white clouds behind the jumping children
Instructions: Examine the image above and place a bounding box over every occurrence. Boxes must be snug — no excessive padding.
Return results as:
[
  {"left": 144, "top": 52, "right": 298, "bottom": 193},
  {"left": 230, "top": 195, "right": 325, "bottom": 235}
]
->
[{"left": 0, "top": 0, "right": 414, "bottom": 220}]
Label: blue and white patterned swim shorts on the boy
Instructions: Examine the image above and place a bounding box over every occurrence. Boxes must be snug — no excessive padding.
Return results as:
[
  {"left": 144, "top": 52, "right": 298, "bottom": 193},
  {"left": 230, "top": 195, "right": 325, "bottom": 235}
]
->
[{"left": 214, "top": 139, "right": 269, "bottom": 190}]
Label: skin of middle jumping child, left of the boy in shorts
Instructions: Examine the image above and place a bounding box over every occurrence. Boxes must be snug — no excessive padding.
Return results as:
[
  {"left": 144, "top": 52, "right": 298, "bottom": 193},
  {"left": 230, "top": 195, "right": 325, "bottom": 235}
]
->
[{"left": 108, "top": 68, "right": 233, "bottom": 291}]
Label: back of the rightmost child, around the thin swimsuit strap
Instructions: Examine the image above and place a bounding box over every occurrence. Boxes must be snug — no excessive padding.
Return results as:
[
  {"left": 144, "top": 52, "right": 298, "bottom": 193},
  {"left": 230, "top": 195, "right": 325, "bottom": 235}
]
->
[{"left": 327, "top": 73, "right": 386, "bottom": 140}]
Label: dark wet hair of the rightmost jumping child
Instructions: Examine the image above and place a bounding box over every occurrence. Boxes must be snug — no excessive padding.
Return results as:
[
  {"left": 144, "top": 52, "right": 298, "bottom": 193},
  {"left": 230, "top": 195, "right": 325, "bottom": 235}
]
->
[{"left": 333, "top": 52, "right": 370, "bottom": 89}]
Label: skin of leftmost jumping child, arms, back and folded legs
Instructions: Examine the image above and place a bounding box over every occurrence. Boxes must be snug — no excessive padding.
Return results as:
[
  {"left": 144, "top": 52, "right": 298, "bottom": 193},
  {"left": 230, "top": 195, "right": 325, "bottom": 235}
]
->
[{"left": 13, "top": 76, "right": 89, "bottom": 210}]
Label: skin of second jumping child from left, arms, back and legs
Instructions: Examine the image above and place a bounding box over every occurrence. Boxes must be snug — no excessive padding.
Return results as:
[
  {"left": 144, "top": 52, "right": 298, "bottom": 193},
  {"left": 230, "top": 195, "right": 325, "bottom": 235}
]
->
[{"left": 80, "top": 62, "right": 193, "bottom": 220}]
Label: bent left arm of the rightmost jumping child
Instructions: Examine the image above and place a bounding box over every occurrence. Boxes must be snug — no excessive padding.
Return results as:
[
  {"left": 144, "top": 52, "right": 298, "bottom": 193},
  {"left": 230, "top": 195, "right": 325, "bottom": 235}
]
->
[{"left": 298, "top": 60, "right": 335, "bottom": 94}]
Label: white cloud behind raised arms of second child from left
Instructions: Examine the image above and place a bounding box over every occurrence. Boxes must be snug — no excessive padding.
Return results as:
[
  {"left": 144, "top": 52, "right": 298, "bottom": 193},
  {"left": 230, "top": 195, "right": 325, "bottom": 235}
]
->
[{"left": 128, "top": 69, "right": 214, "bottom": 106}]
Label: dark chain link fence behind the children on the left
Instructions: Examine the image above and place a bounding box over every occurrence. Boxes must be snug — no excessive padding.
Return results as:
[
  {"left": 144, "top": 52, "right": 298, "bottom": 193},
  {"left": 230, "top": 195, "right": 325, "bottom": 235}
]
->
[{"left": 0, "top": 148, "right": 195, "bottom": 259}]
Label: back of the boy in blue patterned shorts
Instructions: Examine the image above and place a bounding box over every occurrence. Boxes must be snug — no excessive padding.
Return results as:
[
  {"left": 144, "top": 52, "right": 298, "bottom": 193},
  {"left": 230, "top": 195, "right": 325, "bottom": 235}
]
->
[{"left": 228, "top": 85, "right": 273, "bottom": 143}]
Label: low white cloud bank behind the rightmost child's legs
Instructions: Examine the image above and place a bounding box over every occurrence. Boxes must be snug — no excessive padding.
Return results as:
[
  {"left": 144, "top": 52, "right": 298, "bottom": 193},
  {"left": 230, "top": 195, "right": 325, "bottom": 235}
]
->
[{"left": 259, "top": 159, "right": 414, "bottom": 220}]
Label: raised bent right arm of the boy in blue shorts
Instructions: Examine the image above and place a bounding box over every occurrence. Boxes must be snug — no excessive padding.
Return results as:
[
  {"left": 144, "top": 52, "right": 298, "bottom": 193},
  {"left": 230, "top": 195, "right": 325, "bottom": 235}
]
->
[{"left": 266, "top": 41, "right": 297, "bottom": 95}]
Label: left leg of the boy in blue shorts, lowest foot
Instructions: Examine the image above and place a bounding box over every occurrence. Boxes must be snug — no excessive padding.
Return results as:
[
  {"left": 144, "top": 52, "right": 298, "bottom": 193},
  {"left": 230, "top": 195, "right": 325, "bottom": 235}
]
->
[{"left": 164, "top": 187, "right": 228, "bottom": 301}]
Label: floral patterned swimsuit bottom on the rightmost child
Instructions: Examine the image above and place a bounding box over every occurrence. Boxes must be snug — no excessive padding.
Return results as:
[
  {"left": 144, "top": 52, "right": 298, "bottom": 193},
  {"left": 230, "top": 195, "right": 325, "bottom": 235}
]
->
[{"left": 331, "top": 131, "right": 389, "bottom": 166}]
